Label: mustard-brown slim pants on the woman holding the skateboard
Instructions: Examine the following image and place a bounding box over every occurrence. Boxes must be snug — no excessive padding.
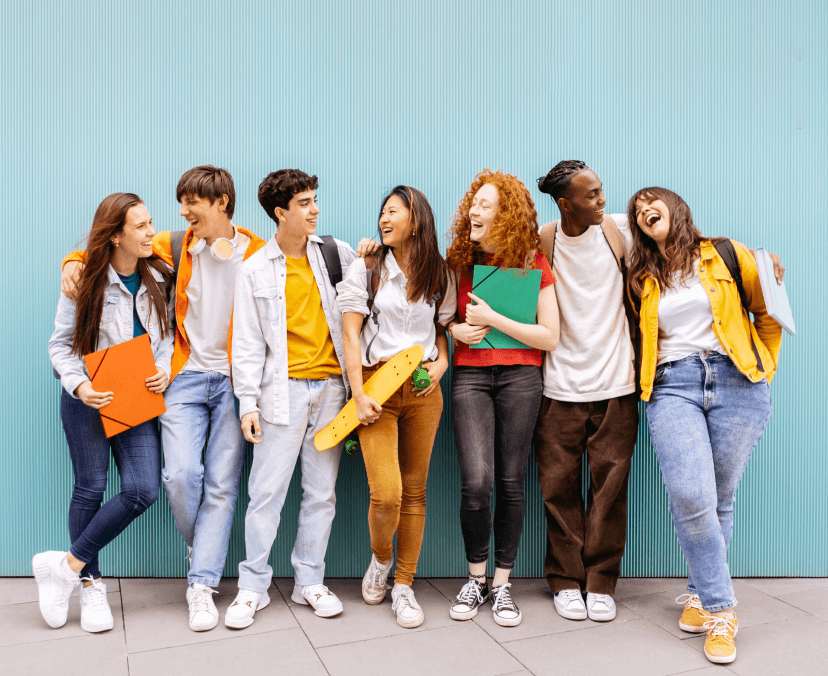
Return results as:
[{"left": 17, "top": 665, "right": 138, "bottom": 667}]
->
[{"left": 357, "top": 367, "right": 443, "bottom": 586}]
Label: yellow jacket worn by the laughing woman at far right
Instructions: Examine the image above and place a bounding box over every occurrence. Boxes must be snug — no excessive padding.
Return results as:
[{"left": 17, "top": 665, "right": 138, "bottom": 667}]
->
[{"left": 639, "top": 240, "right": 782, "bottom": 401}]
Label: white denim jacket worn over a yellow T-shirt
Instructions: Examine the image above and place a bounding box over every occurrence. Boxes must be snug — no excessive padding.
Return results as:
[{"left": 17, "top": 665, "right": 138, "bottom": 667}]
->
[{"left": 231, "top": 235, "right": 357, "bottom": 425}]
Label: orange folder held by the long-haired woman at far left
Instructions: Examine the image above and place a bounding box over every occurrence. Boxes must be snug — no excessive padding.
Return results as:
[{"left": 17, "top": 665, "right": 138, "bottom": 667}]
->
[{"left": 83, "top": 333, "right": 167, "bottom": 439}]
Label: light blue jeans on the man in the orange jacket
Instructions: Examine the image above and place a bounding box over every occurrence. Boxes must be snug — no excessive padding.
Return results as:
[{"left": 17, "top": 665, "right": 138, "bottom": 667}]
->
[{"left": 160, "top": 371, "right": 244, "bottom": 587}]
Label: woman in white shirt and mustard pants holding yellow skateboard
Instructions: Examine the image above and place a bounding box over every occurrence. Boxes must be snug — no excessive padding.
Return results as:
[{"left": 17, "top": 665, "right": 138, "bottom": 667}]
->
[{"left": 337, "top": 185, "right": 457, "bottom": 628}]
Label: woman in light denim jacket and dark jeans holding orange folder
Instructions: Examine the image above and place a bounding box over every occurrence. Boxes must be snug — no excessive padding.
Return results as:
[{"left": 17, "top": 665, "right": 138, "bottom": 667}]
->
[{"left": 32, "top": 193, "right": 173, "bottom": 632}]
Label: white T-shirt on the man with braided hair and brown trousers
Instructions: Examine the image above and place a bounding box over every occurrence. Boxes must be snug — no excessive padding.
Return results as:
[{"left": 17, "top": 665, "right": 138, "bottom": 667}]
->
[{"left": 543, "top": 214, "right": 635, "bottom": 402}]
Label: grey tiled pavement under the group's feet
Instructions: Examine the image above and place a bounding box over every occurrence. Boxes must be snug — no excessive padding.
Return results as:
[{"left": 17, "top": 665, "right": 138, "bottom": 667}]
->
[{"left": 0, "top": 578, "right": 828, "bottom": 676}]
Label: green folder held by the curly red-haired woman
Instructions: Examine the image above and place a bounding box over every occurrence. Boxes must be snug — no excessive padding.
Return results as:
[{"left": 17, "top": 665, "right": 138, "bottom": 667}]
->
[{"left": 471, "top": 265, "right": 541, "bottom": 350}]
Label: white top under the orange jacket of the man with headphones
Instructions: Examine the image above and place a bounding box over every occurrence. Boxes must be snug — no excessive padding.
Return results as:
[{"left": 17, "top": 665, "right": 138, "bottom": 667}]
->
[{"left": 181, "top": 225, "right": 250, "bottom": 377}]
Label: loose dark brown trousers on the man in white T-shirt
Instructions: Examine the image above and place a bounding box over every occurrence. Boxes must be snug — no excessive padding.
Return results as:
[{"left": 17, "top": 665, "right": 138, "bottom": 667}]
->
[{"left": 535, "top": 394, "right": 638, "bottom": 594}]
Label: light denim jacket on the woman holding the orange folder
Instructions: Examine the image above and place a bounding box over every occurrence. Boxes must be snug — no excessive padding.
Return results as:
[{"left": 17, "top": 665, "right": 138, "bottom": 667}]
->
[{"left": 49, "top": 265, "right": 175, "bottom": 399}]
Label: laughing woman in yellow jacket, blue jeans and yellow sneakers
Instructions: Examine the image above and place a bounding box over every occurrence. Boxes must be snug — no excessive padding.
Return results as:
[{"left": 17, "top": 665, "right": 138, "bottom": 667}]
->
[{"left": 627, "top": 188, "right": 782, "bottom": 663}]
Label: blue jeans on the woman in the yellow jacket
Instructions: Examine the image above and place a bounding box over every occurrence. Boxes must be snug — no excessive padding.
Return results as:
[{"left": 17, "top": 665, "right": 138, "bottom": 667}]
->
[{"left": 647, "top": 352, "right": 771, "bottom": 611}]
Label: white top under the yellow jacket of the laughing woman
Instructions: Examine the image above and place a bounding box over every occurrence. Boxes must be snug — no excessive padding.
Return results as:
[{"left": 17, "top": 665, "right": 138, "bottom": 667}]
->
[{"left": 658, "top": 260, "right": 727, "bottom": 364}]
